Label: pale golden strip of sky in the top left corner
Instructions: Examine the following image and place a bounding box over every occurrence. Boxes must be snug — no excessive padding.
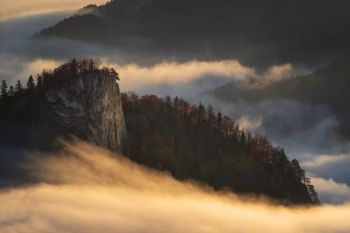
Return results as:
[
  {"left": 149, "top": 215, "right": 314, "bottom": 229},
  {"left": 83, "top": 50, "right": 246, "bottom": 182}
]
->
[{"left": 0, "top": 0, "right": 106, "bottom": 21}]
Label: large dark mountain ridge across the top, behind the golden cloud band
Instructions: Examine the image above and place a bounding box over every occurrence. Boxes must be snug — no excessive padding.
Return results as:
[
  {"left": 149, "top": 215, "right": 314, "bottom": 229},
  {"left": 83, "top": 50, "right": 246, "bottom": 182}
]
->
[{"left": 38, "top": 0, "right": 350, "bottom": 65}]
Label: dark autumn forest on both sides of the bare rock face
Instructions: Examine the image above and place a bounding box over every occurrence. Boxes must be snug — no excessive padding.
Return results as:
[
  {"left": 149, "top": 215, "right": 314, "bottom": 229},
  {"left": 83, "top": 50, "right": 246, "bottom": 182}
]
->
[{"left": 0, "top": 59, "right": 318, "bottom": 204}]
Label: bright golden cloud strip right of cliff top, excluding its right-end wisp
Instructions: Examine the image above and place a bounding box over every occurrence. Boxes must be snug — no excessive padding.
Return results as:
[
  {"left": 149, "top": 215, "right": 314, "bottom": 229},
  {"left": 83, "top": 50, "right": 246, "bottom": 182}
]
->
[{"left": 109, "top": 60, "right": 254, "bottom": 90}]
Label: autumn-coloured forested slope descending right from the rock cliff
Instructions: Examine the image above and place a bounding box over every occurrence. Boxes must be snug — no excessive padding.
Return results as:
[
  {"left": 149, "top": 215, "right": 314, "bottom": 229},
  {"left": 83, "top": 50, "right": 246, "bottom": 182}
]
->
[{"left": 123, "top": 94, "right": 318, "bottom": 203}]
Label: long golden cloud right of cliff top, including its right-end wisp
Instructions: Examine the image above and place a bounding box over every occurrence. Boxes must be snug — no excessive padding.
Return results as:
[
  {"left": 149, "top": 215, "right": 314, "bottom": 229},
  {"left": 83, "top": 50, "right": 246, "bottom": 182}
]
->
[{"left": 102, "top": 59, "right": 293, "bottom": 94}]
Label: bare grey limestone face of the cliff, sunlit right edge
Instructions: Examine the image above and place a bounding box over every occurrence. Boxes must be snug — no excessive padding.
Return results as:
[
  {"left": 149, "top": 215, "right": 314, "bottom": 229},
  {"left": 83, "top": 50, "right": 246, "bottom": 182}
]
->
[{"left": 45, "top": 72, "right": 126, "bottom": 152}]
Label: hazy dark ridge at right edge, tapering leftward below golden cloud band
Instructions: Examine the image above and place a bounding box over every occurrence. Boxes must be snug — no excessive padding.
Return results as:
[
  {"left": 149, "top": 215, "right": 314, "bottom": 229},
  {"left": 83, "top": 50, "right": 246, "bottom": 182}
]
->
[{"left": 209, "top": 60, "right": 350, "bottom": 138}]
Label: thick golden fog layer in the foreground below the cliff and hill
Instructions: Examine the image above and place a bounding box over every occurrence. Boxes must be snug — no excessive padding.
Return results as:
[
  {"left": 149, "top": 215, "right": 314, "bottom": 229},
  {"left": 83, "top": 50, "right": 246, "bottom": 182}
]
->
[{"left": 0, "top": 140, "right": 350, "bottom": 233}]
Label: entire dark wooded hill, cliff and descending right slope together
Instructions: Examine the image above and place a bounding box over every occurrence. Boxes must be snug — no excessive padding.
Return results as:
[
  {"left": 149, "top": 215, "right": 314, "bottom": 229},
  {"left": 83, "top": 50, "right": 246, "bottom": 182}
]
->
[{"left": 0, "top": 59, "right": 318, "bottom": 204}]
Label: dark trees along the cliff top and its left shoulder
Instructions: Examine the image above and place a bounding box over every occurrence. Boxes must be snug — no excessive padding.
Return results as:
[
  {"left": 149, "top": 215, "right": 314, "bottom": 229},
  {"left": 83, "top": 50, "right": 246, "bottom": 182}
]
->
[{"left": 0, "top": 58, "right": 119, "bottom": 124}]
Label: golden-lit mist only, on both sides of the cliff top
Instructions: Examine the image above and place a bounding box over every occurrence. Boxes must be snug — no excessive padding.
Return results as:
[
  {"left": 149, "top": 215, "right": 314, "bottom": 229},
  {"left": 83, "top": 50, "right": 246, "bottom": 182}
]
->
[{"left": 10, "top": 58, "right": 293, "bottom": 92}]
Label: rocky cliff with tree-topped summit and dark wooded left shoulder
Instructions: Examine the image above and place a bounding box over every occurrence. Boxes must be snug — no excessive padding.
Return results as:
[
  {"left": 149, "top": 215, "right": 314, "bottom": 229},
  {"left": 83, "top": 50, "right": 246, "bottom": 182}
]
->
[{"left": 0, "top": 60, "right": 126, "bottom": 152}]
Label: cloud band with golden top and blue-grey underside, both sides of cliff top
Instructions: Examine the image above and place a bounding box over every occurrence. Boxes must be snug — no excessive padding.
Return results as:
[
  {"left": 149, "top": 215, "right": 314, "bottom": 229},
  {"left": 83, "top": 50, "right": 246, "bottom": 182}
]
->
[{"left": 0, "top": 54, "right": 296, "bottom": 97}]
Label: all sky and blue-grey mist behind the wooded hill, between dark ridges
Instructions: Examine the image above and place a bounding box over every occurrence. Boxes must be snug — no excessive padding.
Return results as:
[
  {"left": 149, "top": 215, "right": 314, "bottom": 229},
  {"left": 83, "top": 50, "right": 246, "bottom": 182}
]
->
[{"left": 0, "top": 0, "right": 350, "bottom": 206}]
